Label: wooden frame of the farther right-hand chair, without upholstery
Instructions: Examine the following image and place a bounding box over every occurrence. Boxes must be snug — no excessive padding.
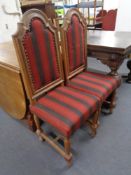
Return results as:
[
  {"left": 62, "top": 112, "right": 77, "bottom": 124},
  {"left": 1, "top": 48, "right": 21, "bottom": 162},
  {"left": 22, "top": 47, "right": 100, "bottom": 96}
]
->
[{"left": 60, "top": 8, "right": 116, "bottom": 114}]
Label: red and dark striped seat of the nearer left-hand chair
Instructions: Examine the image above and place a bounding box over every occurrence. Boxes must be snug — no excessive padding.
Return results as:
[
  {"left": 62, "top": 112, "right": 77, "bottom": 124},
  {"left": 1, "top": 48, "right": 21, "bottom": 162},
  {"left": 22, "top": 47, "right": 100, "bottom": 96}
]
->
[{"left": 30, "top": 86, "right": 100, "bottom": 137}]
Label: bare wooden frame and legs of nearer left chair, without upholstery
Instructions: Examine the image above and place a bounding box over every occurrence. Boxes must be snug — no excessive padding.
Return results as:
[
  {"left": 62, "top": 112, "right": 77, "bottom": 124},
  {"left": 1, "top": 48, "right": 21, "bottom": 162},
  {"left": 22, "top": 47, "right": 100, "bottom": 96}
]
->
[{"left": 12, "top": 9, "right": 72, "bottom": 165}]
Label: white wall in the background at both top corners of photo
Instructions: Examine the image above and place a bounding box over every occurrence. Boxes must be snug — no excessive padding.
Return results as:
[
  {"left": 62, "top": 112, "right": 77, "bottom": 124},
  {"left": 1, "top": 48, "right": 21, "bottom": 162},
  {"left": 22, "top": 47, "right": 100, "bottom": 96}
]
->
[{"left": 0, "top": 0, "right": 131, "bottom": 36}]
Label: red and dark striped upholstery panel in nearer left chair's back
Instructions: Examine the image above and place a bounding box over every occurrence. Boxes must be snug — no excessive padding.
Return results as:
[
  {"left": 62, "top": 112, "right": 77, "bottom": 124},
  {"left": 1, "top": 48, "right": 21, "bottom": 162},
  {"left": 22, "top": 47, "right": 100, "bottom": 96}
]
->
[{"left": 23, "top": 18, "right": 59, "bottom": 90}]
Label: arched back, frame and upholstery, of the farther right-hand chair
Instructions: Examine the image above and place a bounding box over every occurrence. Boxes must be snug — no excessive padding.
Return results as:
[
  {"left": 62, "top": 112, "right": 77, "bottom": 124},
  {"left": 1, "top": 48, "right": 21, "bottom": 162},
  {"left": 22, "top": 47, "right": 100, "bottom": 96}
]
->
[{"left": 61, "top": 9, "right": 87, "bottom": 79}]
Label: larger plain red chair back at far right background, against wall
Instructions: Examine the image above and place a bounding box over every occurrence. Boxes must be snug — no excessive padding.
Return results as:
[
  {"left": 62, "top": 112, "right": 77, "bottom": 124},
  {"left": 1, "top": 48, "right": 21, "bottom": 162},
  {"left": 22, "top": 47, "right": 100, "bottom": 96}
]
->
[{"left": 102, "top": 9, "right": 117, "bottom": 31}]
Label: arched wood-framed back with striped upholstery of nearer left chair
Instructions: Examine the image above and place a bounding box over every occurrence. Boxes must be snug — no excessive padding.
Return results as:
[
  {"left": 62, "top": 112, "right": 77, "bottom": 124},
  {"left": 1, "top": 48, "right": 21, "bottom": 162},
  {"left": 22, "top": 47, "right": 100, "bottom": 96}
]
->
[{"left": 14, "top": 9, "right": 63, "bottom": 99}]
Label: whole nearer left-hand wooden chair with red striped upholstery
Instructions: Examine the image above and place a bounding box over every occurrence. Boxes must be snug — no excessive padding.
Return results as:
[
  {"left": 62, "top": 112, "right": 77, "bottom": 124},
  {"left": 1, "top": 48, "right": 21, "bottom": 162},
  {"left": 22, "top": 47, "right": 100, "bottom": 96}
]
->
[{"left": 13, "top": 9, "right": 100, "bottom": 165}]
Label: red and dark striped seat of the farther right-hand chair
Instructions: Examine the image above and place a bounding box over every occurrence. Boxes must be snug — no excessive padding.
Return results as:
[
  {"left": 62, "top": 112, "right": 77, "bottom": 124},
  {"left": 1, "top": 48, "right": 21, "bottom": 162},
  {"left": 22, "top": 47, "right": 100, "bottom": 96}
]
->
[{"left": 69, "top": 71, "right": 121, "bottom": 101}]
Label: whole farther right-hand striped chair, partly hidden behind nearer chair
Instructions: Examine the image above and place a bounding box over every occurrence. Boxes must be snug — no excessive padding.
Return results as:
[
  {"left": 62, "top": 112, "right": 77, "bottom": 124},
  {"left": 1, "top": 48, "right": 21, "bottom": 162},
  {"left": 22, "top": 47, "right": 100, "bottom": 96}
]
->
[{"left": 61, "top": 9, "right": 120, "bottom": 113}]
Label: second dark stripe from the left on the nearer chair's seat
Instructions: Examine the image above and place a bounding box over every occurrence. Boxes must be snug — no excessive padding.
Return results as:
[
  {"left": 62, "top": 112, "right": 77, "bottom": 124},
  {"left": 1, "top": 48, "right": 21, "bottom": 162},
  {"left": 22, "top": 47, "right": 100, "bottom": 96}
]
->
[{"left": 46, "top": 95, "right": 83, "bottom": 124}]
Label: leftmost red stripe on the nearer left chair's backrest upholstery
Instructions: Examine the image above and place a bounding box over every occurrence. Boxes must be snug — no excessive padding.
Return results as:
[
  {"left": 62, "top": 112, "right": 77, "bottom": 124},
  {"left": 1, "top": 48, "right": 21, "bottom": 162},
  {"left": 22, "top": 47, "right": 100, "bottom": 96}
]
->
[{"left": 23, "top": 33, "right": 41, "bottom": 90}]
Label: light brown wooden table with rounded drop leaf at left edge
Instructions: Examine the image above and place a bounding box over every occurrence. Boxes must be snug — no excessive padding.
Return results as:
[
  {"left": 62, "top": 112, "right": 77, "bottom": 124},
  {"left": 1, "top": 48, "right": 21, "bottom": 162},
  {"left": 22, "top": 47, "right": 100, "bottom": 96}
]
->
[{"left": 0, "top": 41, "right": 26, "bottom": 119}]
